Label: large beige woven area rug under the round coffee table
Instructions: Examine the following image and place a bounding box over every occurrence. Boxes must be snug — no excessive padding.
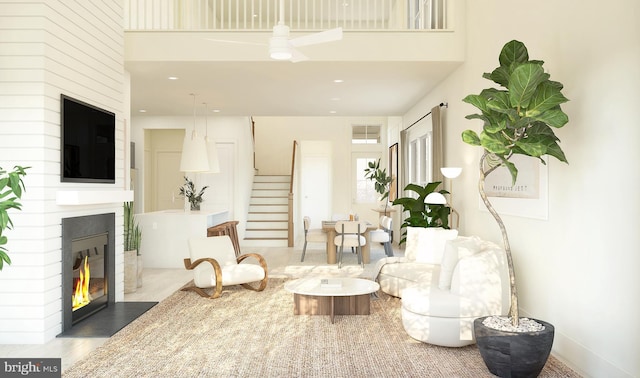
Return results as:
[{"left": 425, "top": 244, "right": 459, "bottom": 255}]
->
[{"left": 62, "top": 279, "right": 579, "bottom": 378}]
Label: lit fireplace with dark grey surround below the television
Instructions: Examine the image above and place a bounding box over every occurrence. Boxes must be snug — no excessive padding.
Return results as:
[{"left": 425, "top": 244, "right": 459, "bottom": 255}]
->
[{"left": 62, "top": 213, "right": 115, "bottom": 332}]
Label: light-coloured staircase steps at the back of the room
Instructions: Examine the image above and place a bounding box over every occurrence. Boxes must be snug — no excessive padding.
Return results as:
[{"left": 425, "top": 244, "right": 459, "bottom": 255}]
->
[{"left": 242, "top": 175, "right": 291, "bottom": 247}]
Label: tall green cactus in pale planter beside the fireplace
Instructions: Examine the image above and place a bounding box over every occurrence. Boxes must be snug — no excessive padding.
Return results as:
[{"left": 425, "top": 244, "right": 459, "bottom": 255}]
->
[{"left": 124, "top": 201, "right": 142, "bottom": 293}]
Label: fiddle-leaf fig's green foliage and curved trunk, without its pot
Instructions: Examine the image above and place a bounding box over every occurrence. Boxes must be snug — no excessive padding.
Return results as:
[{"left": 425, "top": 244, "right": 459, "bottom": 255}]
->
[{"left": 462, "top": 40, "right": 569, "bottom": 327}]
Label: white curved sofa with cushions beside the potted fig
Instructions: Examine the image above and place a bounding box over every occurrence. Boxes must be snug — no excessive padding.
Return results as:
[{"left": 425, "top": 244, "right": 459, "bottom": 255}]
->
[{"left": 377, "top": 227, "right": 510, "bottom": 347}]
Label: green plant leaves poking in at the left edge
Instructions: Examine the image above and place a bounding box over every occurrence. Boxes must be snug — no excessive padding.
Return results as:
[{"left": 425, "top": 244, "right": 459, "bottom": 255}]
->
[{"left": 0, "top": 166, "right": 31, "bottom": 270}]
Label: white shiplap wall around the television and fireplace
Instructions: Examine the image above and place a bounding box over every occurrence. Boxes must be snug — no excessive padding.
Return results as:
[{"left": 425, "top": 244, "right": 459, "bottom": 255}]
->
[{"left": 0, "top": 0, "right": 128, "bottom": 344}]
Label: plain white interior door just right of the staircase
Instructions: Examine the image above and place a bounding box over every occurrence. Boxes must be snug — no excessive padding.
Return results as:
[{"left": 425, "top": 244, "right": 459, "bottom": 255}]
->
[{"left": 300, "top": 141, "right": 333, "bottom": 228}]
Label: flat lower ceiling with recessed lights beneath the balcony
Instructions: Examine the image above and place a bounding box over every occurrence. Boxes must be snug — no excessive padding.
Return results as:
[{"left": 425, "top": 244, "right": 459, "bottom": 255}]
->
[{"left": 127, "top": 57, "right": 458, "bottom": 116}]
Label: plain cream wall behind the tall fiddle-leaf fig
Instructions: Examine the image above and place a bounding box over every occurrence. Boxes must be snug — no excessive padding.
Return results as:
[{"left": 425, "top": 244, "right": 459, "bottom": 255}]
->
[{"left": 404, "top": 0, "right": 640, "bottom": 377}]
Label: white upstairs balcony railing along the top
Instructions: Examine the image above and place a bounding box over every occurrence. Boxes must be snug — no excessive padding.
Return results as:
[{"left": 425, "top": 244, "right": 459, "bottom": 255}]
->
[{"left": 125, "top": 0, "right": 452, "bottom": 31}]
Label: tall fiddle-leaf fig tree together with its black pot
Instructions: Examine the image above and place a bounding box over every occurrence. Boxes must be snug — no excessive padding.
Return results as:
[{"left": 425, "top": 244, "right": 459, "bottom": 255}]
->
[{"left": 462, "top": 40, "right": 569, "bottom": 377}]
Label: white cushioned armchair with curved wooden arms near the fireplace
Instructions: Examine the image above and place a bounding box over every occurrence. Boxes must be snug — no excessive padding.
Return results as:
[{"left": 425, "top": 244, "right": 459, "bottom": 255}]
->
[{"left": 182, "top": 235, "right": 268, "bottom": 299}]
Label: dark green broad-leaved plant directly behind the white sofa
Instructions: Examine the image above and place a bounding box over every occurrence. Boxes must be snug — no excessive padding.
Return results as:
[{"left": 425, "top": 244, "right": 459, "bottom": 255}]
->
[{"left": 393, "top": 181, "right": 451, "bottom": 244}]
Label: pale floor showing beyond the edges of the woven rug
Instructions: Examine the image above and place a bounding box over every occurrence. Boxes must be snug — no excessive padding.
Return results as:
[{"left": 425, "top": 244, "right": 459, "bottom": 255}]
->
[{"left": 0, "top": 246, "right": 399, "bottom": 372}]
